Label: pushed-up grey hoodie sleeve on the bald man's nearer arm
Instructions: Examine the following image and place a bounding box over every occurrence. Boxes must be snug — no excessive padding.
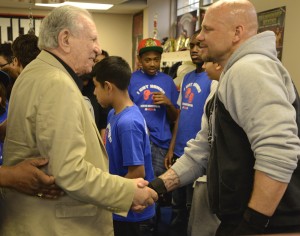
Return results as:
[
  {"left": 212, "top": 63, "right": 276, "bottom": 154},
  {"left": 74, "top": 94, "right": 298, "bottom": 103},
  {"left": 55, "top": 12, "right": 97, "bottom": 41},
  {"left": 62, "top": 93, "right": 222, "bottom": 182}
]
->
[{"left": 218, "top": 56, "right": 300, "bottom": 183}]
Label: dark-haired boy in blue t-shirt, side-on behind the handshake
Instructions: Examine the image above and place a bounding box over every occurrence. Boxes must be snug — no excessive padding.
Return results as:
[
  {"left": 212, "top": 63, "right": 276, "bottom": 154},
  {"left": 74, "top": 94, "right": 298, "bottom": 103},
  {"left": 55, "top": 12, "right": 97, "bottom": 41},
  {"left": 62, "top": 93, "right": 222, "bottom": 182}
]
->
[{"left": 93, "top": 56, "right": 155, "bottom": 236}]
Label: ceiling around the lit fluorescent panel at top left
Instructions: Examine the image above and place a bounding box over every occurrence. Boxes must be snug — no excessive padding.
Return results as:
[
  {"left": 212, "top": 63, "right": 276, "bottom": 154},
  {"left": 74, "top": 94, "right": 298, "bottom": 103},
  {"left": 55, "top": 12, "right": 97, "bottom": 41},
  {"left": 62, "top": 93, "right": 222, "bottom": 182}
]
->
[{"left": 0, "top": 0, "right": 147, "bottom": 14}]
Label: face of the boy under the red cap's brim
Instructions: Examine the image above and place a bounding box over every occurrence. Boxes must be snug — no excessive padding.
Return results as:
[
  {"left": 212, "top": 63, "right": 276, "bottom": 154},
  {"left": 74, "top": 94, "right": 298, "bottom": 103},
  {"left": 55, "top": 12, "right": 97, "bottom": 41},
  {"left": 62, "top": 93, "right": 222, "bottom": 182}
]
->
[{"left": 139, "top": 51, "right": 161, "bottom": 75}]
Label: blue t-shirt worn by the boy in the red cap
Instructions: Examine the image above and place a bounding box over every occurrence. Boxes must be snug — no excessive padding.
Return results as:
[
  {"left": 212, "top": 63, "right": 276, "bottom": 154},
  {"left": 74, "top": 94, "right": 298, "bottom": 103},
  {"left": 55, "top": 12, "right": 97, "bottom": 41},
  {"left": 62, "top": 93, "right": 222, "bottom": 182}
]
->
[{"left": 128, "top": 70, "right": 178, "bottom": 149}]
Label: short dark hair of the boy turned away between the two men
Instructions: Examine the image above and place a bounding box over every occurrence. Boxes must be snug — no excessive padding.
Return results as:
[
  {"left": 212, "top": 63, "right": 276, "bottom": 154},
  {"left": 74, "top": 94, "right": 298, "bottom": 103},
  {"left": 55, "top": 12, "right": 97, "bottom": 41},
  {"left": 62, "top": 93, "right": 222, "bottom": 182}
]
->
[{"left": 93, "top": 56, "right": 131, "bottom": 90}]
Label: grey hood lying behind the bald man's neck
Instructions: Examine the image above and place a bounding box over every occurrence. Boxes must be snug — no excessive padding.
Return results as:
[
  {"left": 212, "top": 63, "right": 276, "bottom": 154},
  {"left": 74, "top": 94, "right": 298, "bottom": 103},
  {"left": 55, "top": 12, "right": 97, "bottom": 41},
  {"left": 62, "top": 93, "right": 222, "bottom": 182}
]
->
[{"left": 224, "top": 31, "right": 279, "bottom": 73}]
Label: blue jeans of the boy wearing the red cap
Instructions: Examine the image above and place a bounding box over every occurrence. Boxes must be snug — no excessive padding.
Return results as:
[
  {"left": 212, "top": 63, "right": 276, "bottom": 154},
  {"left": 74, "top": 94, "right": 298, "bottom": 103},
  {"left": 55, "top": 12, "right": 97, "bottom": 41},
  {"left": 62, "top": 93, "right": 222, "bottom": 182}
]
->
[{"left": 151, "top": 142, "right": 168, "bottom": 177}]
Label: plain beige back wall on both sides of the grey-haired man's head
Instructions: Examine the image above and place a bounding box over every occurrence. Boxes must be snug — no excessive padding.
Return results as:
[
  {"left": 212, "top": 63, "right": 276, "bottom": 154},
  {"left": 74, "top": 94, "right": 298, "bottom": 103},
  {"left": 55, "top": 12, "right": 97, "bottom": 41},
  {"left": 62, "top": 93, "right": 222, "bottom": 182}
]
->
[{"left": 0, "top": 8, "right": 132, "bottom": 66}]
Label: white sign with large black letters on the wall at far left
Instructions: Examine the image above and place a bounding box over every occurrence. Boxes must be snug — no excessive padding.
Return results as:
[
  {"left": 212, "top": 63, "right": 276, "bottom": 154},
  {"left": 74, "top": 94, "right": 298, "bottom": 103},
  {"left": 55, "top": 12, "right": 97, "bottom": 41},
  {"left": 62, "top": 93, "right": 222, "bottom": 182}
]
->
[{"left": 0, "top": 14, "right": 44, "bottom": 43}]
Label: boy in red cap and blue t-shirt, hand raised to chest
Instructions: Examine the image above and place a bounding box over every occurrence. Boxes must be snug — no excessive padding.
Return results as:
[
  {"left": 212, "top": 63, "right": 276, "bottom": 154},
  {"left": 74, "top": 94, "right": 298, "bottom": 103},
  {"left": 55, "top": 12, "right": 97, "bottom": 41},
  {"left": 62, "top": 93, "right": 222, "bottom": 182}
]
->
[{"left": 128, "top": 38, "right": 179, "bottom": 177}]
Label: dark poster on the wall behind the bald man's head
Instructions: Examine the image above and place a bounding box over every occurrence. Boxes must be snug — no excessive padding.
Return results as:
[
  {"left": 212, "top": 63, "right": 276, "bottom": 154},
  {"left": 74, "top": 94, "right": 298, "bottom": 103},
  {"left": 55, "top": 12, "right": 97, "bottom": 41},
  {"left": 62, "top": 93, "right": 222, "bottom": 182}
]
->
[{"left": 257, "top": 6, "right": 286, "bottom": 60}]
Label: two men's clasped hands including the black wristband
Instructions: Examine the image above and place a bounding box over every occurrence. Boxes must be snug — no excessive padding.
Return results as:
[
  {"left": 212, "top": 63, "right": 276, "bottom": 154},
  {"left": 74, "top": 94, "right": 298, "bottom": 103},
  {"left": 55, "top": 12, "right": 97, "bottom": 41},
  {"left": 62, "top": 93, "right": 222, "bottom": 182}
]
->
[{"left": 131, "top": 178, "right": 167, "bottom": 212}]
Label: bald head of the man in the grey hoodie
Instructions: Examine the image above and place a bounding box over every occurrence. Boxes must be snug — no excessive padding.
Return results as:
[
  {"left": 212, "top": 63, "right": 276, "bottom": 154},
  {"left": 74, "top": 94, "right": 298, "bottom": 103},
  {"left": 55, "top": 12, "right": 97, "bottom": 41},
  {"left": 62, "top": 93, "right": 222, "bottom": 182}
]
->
[{"left": 197, "top": 0, "right": 258, "bottom": 67}]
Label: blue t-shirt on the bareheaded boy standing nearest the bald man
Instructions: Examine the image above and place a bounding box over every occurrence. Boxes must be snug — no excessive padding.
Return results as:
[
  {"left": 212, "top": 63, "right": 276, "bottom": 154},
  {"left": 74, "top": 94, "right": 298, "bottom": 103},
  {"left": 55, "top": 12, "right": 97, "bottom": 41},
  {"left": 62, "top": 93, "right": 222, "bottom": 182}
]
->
[{"left": 174, "top": 70, "right": 211, "bottom": 157}]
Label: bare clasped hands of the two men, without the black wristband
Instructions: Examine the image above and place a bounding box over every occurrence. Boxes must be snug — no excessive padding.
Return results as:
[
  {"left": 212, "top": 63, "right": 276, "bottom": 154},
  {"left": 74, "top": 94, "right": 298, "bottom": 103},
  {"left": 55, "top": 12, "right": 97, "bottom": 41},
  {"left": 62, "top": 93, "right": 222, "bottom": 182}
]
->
[{"left": 131, "top": 178, "right": 158, "bottom": 212}]
